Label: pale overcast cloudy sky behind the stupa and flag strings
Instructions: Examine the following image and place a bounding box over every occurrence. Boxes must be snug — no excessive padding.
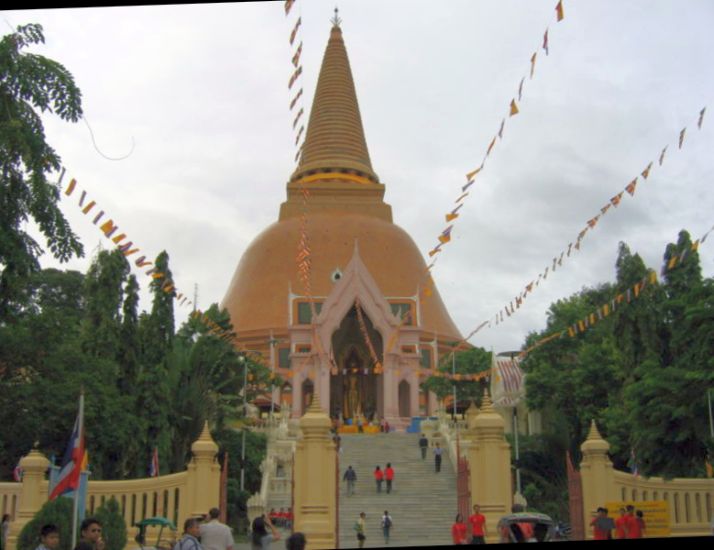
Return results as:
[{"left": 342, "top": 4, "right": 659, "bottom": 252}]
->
[{"left": 2, "top": 0, "right": 714, "bottom": 351}]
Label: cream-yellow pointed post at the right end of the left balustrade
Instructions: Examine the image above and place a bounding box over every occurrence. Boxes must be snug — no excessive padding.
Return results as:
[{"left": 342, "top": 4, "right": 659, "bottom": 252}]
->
[{"left": 185, "top": 421, "right": 221, "bottom": 523}]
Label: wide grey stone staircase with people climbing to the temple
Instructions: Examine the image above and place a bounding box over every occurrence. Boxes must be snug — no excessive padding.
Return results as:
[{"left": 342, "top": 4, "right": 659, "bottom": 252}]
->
[{"left": 339, "top": 432, "right": 456, "bottom": 548}]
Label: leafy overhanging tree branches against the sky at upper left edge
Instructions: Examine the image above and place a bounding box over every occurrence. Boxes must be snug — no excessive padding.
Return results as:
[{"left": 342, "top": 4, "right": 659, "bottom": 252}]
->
[{"left": 0, "top": 24, "right": 84, "bottom": 322}]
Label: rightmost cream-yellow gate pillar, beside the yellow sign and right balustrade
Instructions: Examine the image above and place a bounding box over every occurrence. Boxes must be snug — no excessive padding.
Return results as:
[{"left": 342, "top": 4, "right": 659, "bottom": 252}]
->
[{"left": 580, "top": 420, "right": 619, "bottom": 539}]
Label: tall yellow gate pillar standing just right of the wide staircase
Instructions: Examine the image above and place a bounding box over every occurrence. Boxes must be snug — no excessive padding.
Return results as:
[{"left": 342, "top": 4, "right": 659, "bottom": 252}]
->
[{"left": 467, "top": 393, "right": 513, "bottom": 542}]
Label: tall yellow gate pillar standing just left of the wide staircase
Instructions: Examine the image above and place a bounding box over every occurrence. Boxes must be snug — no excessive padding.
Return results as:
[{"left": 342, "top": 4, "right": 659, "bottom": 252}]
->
[{"left": 294, "top": 393, "right": 337, "bottom": 550}]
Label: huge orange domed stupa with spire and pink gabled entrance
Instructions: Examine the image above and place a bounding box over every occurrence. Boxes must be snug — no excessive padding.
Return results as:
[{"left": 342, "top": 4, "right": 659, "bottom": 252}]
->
[{"left": 221, "top": 20, "right": 461, "bottom": 426}]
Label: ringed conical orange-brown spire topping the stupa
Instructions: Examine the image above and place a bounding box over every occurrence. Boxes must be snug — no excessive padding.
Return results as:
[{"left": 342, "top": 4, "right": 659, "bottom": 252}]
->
[{"left": 290, "top": 12, "right": 379, "bottom": 183}]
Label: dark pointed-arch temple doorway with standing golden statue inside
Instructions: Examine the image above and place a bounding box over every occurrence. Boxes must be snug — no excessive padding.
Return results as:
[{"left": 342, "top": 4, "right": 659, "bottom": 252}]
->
[{"left": 330, "top": 306, "right": 383, "bottom": 424}]
